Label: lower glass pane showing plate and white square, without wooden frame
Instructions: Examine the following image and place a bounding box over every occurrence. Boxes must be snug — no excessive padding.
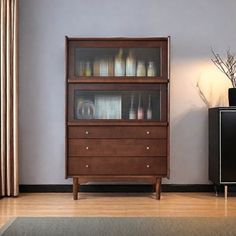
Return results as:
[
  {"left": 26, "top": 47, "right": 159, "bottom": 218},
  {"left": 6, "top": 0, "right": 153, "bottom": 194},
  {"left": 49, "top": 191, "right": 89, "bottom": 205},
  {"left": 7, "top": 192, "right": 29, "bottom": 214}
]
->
[{"left": 74, "top": 89, "right": 162, "bottom": 121}]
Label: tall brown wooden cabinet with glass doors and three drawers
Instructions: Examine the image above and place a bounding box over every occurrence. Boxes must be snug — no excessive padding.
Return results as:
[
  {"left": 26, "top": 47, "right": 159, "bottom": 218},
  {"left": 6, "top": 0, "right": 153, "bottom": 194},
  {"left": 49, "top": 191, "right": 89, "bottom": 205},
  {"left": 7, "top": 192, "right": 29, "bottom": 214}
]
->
[{"left": 66, "top": 37, "right": 170, "bottom": 199}]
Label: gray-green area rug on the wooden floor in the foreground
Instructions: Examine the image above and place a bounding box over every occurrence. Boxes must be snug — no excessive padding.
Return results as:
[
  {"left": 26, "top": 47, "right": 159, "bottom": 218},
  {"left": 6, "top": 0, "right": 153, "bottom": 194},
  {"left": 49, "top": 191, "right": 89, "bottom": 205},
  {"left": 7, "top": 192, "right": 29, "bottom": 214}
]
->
[{"left": 0, "top": 217, "right": 236, "bottom": 236}]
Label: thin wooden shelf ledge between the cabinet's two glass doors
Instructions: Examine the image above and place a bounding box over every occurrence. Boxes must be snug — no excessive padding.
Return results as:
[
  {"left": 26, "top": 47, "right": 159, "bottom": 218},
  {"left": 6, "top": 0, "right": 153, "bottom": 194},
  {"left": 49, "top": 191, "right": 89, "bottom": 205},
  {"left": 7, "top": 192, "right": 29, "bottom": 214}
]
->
[{"left": 68, "top": 76, "right": 169, "bottom": 84}]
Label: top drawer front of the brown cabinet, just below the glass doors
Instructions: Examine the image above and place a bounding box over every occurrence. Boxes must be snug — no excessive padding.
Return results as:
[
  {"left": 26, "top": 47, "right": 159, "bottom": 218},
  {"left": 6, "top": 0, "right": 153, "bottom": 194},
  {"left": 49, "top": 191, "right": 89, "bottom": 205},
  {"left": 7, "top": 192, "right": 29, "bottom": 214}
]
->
[{"left": 68, "top": 126, "right": 167, "bottom": 139}]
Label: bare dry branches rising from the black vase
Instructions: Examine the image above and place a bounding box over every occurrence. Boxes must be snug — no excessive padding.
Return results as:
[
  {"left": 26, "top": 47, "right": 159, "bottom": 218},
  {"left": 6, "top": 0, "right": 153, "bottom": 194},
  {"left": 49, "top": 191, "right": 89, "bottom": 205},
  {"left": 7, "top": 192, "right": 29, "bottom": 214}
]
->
[{"left": 211, "top": 49, "right": 236, "bottom": 88}]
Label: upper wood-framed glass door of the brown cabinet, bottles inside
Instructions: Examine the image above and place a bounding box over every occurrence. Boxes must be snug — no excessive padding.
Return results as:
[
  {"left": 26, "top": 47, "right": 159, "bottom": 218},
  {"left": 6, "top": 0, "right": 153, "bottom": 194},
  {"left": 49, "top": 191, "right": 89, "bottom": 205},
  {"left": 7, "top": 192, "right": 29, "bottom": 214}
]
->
[{"left": 68, "top": 38, "right": 168, "bottom": 79}]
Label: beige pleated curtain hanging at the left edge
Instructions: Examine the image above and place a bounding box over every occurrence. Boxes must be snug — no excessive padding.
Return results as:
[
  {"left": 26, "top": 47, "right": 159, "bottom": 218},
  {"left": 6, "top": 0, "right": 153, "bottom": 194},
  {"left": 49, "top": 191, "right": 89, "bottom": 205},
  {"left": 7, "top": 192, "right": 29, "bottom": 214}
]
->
[{"left": 0, "top": 0, "right": 19, "bottom": 197}]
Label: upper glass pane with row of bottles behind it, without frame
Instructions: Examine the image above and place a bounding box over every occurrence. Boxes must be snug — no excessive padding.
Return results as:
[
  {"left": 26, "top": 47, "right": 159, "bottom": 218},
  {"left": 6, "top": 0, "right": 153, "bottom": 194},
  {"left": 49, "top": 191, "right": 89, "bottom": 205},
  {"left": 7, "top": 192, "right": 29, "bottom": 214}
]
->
[{"left": 74, "top": 48, "right": 161, "bottom": 76}]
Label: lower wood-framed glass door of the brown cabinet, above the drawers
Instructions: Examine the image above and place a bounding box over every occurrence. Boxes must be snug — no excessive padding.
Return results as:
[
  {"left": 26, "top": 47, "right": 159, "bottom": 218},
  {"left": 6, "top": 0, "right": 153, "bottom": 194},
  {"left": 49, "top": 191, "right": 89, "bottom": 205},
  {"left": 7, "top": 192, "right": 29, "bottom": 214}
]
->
[{"left": 69, "top": 85, "right": 166, "bottom": 121}]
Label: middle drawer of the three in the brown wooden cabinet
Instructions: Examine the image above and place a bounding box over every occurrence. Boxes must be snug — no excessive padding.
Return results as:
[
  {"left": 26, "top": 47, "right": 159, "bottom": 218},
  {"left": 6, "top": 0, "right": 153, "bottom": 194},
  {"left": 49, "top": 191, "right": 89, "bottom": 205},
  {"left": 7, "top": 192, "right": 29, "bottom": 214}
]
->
[{"left": 68, "top": 139, "right": 167, "bottom": 156}]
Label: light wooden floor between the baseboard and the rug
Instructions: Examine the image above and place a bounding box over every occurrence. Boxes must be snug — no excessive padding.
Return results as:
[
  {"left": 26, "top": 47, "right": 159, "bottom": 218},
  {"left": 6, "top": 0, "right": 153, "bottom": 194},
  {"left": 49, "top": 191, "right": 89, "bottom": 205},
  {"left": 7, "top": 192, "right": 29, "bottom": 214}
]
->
[{"left": 0, "top": 193, "right": 236, "bottom": 227}]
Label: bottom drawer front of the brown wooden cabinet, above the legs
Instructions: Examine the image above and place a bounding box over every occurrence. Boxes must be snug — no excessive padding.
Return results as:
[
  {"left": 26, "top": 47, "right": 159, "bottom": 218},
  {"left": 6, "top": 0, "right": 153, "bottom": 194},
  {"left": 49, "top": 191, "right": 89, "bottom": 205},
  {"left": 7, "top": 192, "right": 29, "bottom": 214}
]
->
[{"left": 68, "top": 157, "right": 167, "bottom": 176}]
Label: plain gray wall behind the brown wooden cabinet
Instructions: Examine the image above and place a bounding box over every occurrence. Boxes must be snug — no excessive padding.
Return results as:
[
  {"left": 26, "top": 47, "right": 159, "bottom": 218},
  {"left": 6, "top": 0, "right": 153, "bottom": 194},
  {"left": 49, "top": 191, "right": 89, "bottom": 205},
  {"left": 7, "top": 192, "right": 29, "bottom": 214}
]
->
[{"left": 20, "top": 0, "right": 236, "bottom": 184}]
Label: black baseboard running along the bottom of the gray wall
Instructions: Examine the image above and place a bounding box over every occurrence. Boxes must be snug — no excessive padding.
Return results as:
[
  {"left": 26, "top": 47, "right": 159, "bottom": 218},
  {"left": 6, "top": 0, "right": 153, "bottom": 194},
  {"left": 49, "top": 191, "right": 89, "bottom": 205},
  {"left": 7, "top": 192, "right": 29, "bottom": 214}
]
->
[{"left": 20, "top": 184, "right": 236, "bottom": 193}]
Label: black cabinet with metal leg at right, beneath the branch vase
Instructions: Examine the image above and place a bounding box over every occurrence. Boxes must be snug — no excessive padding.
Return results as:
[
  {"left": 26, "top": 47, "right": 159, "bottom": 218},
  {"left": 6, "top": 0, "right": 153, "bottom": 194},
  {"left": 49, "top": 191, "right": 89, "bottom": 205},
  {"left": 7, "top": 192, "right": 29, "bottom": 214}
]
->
[{"left": 209, "top": 107, "right": 236, "bottom": 196}]
